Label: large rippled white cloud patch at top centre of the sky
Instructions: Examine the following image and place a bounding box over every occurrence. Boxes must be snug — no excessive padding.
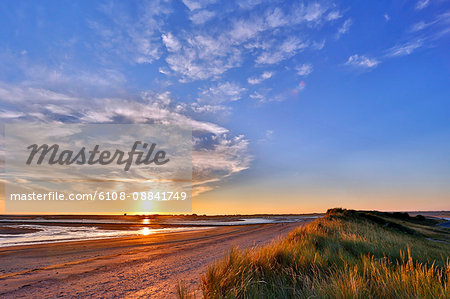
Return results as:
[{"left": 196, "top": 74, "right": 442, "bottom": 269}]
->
[{"left": 162, "top": 0, "right": 342, "bottom": 82}]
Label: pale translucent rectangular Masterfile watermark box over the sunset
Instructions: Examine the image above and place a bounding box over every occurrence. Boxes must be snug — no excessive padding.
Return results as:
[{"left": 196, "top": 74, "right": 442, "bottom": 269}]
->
[{"left": 3, "top": 124, "right": 192, "bottom": 214}]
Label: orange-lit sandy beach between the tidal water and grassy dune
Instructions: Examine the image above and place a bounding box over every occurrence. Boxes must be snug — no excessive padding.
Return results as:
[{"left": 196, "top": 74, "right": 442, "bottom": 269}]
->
[{"left": 0, "top": 220, "right": 308, "bottom": 298}]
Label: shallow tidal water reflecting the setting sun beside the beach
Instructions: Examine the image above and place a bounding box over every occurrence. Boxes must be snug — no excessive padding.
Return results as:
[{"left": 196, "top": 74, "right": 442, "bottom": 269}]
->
[{"left": 0, "top": 216, "right": 317, "bottom": 247}]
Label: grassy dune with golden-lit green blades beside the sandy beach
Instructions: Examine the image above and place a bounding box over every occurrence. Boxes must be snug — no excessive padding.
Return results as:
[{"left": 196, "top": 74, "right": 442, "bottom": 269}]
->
[{"left": 178, "top": 209, "right": 450, "bottom": 298}]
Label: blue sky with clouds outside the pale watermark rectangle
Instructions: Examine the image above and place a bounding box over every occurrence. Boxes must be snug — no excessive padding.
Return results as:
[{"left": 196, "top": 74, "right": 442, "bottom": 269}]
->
[{"left": 0, "top": 0, "right": 450, "bottom": 214}]
